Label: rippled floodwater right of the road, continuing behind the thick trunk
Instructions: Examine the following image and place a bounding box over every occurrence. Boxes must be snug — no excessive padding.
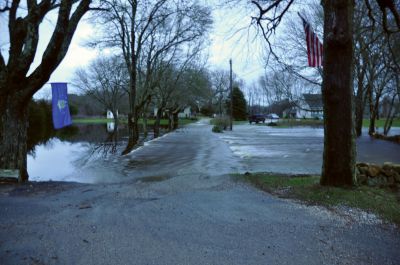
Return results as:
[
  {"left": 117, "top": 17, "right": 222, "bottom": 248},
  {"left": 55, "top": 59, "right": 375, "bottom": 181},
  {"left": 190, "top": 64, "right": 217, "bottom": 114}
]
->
[{"left": 220, "top": 125, "right": 400, "bottom": 174}]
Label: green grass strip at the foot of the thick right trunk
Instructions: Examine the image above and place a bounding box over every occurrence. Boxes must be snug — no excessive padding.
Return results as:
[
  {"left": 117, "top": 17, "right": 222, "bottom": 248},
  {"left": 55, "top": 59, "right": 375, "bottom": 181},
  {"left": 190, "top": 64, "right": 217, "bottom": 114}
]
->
[{"left": 242, "top": 173, "right": 400, "bottom": 225}]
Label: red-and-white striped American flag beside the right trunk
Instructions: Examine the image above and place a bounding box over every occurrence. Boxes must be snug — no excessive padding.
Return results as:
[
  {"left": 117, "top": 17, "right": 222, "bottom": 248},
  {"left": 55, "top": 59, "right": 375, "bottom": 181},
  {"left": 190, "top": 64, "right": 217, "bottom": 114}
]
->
[{"left": 299, "top": 13, "right": 323, "bottom": 67}]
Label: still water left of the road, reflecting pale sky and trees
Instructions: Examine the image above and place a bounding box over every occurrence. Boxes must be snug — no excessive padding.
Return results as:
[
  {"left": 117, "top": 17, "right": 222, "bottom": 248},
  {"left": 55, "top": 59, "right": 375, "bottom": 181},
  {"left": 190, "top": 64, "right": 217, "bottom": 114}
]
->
[{"left": 28, "top": 123, "right": 166, "bottom": 182}]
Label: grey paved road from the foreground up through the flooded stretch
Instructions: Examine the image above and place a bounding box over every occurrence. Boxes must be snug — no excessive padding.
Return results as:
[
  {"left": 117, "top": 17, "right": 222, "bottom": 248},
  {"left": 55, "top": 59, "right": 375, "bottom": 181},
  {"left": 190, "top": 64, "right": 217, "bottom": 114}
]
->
[{"left": 0, "top": 119, "right": 400, "bottom": 264}]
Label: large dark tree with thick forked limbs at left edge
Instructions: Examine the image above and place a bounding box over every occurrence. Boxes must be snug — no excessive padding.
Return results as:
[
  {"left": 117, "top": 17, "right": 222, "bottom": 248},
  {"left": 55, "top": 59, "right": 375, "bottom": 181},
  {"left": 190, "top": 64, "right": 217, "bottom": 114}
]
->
[{"left": 0, "top": 0, "right": 98, "bottom": 181}]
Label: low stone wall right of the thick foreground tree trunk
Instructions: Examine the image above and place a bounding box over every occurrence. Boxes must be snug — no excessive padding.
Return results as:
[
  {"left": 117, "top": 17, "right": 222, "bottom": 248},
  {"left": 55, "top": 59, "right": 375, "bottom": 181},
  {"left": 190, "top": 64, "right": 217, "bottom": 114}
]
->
[{"left": 356, "top": 162, "right": 400, "bottom": 187}]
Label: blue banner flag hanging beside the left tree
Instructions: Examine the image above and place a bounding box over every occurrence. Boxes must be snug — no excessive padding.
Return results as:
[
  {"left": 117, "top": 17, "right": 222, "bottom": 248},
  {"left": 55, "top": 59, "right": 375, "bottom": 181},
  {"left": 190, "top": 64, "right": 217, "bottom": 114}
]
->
[{"left": 51, "top": 83, "right": 72, "bottom": 129}]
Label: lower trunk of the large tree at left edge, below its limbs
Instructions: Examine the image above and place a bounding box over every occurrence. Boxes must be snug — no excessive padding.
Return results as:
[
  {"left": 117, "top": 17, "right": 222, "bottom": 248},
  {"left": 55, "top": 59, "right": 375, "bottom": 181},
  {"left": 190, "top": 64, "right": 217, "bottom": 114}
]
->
[{"left": 0, "top": 96, "right": 28, "bottom": 182}]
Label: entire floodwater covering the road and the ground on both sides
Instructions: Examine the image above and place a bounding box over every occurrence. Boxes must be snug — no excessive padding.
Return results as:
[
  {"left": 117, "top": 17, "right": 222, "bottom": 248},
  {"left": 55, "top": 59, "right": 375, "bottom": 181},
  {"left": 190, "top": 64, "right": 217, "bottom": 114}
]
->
[{"left": 28, "top": 120, "right": 400, "bottom": 183}]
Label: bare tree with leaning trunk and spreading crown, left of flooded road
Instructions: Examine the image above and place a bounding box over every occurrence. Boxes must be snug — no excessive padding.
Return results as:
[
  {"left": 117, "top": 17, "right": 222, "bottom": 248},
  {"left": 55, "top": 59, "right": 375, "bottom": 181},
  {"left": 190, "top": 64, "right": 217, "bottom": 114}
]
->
[{"left": 93, "top": 0, "right": 211, "bottom": 153}]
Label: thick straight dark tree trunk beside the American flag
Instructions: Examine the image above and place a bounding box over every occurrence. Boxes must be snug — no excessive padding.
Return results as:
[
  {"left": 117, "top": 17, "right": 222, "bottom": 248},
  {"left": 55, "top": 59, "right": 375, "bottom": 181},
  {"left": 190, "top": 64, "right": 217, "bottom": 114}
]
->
[{"left": 321, "top": 0, "right": 355, "bottom": 186}]
